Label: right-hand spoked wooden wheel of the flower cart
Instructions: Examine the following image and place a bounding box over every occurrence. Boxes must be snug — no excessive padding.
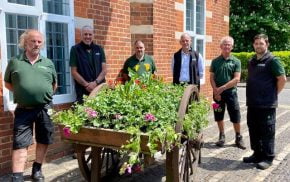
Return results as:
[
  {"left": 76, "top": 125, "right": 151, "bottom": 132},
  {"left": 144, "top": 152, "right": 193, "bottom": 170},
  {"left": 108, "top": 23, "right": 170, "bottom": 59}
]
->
[{"left": 166, "top": 85, "right": 202, "bottom": 182}]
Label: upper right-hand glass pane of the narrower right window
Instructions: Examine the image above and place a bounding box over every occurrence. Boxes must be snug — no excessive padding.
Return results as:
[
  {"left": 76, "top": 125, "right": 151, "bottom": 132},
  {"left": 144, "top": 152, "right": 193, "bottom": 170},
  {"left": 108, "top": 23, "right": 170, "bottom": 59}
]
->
[{"left": 196, "top": 0, "right": 204, "bottom": 35}]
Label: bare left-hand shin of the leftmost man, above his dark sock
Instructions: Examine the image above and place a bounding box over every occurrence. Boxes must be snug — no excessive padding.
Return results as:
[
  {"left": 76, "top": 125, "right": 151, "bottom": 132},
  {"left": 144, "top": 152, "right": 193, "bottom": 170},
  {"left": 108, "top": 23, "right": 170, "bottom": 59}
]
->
[{"left": 12, "top": 148, "right": 27, "bottom": 173}]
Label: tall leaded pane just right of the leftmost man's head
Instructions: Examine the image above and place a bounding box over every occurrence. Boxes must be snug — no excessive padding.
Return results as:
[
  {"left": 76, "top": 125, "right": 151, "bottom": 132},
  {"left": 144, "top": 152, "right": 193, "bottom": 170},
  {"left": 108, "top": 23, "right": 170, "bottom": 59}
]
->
[{"left": 46, "top": 22, "right": 71, "bottom": 94}]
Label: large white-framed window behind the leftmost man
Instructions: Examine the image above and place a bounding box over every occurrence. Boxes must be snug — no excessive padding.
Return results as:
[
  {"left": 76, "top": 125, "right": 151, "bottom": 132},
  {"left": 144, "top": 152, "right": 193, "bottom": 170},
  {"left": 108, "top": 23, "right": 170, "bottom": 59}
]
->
[{"left": 0, "top": 0, "right": 75, "bottom": 110}]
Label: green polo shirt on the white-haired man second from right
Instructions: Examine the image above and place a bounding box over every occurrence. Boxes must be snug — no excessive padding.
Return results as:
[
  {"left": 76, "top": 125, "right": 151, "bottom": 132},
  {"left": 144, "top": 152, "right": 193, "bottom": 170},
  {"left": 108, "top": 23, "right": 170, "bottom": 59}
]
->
[{"left": 210, "top": 55, "right": 241, "bottom": 90}]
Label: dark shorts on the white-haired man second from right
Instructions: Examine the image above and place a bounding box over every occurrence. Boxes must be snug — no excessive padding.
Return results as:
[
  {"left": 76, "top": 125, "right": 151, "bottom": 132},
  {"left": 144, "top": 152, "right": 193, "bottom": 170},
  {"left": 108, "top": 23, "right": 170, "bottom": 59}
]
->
[{"left": 214, "top": 90, "right": 241, "bottom": 123}]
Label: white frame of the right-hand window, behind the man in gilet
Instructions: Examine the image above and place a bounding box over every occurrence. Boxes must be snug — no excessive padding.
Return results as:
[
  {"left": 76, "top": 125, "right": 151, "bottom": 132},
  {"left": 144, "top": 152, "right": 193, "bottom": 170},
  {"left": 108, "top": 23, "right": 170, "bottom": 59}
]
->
[{"left": 183, "top": 0, "right": 206, "bottom": 84}]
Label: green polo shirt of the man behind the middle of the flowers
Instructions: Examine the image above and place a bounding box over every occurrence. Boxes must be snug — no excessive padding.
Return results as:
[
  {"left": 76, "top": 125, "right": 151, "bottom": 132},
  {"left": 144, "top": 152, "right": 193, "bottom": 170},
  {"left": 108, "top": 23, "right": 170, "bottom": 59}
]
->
[{"left": 123, "top": 54, "right": 156, "bottom": 75}]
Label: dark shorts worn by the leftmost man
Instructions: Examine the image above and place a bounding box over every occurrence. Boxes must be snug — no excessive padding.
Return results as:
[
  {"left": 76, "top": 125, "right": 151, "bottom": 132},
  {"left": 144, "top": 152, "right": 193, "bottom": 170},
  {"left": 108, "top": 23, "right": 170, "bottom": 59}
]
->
[{"left": 13, "top": 107, "right": 54, "bottom": 150}]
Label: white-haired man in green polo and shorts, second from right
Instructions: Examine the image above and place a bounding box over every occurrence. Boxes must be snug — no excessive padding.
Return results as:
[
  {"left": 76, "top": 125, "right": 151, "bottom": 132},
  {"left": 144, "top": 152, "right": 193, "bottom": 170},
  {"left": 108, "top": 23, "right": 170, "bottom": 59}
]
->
[{"left": 210, "top": 36, "right": 246, "bottom": 149}]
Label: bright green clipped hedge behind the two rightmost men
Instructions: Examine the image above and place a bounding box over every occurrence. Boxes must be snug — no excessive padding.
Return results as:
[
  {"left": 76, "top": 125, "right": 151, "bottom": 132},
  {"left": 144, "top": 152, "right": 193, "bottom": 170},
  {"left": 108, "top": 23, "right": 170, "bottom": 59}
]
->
[{"left": 232, "top": 51, "right": 290, "bottom": 81}]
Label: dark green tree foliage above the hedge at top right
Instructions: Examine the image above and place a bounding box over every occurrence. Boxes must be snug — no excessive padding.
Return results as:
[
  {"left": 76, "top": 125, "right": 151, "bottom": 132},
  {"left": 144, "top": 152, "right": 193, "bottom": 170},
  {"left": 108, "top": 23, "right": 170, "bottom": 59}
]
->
[{"left": 230, "top": 0, "right": 290, "bottom": 52}]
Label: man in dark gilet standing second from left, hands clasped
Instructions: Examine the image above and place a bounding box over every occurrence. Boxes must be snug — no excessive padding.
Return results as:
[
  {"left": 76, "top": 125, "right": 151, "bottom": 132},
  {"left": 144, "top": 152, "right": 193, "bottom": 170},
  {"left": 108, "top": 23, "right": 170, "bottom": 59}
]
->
[{"left": 70, "top": 25, "right": 107, "bottom": 103}]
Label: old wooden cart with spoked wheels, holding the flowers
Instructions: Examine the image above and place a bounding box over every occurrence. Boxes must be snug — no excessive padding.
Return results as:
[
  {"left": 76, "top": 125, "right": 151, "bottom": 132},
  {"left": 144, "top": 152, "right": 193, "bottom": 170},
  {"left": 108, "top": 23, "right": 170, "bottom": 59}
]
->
[{"left": 59, "top": 84, "right": 202, "bottom": 182}]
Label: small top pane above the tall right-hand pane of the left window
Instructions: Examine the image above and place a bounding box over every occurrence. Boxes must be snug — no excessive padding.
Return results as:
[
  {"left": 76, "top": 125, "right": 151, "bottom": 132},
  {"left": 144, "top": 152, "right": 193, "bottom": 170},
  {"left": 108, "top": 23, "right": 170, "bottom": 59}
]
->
[{"left": 42, "top": 0, "right": 70, "bottom": 16}]
